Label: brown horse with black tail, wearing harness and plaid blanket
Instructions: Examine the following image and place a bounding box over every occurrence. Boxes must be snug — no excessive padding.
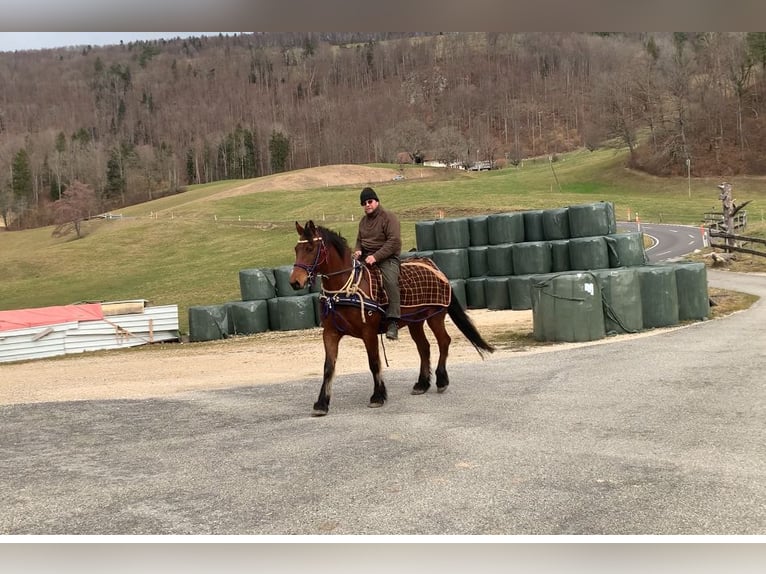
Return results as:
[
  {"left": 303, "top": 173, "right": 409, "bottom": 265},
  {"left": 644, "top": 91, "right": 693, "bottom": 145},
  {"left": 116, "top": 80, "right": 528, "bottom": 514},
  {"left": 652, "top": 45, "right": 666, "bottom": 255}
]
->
[{"left": 289, "top": 220, "right": 495, "bottom": 416}]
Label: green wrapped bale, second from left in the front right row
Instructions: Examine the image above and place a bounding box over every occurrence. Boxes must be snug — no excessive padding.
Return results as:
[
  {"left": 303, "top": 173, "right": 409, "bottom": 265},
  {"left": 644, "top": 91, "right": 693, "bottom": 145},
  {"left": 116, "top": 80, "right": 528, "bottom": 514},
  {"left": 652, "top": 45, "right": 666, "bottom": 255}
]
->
[{"left": 591, "top": 267, "right": 644, "bottom": 335}]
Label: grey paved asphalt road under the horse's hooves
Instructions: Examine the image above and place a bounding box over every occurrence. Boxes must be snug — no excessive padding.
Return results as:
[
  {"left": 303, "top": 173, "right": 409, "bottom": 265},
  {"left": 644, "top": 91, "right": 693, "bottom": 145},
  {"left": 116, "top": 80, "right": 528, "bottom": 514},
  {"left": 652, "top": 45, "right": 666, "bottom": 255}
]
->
[{"left": 0, "top": 227, "right": 766, "bottom": 535}]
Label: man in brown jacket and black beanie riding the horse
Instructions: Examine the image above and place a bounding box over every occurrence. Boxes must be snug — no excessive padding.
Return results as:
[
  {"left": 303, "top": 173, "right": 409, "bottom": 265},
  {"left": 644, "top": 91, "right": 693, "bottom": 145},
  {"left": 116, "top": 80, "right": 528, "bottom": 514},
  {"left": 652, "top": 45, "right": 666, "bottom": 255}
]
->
[{"left": 353, "top": 187, "right": 402, "bottom": 340}]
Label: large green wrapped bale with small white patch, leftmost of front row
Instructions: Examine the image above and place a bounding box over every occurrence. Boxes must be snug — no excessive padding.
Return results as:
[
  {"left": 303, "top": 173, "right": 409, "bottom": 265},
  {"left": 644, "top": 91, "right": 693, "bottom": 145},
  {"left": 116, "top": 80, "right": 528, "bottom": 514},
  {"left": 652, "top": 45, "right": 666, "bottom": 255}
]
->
[{"left": 532, "top": 272, "right": 606, "bottom": 342}]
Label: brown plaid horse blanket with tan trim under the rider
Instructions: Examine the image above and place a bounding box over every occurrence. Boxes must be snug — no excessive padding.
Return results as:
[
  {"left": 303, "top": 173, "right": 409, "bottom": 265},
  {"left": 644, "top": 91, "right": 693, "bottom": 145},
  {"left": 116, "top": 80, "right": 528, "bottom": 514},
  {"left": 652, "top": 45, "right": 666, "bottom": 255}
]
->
[{"left": 366, "top": 257, "right": 452, "bottom": 307}]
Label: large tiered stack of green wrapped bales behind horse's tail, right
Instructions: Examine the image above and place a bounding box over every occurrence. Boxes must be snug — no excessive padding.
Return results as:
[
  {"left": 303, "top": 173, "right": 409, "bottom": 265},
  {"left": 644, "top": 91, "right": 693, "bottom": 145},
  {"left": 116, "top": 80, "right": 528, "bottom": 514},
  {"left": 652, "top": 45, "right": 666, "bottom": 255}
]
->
[{"left": 412, "top": 202, "right": 709, "bottom": 341}]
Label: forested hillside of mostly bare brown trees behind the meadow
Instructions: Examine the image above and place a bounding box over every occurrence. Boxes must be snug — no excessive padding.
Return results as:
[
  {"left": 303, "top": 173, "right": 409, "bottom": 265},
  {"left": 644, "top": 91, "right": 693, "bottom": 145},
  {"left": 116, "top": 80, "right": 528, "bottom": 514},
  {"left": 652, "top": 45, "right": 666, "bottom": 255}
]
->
[{"left": 0, "top": 32, "right": 766, "bottom": 229}]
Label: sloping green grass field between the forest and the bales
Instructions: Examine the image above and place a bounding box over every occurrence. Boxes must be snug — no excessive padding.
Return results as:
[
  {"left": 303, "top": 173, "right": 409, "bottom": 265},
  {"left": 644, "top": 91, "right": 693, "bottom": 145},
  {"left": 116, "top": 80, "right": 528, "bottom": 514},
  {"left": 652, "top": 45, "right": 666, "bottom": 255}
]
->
[{"left": 0, "top": 149, "right": 766, "bottom": 333}]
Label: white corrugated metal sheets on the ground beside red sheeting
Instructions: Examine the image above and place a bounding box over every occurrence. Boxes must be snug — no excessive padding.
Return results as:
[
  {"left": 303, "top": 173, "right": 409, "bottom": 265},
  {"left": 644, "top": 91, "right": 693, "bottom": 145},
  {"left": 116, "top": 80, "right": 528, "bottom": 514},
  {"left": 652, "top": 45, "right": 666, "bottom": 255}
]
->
[{"left": 0, "top": 305, "right": 179, "bottom": 362}]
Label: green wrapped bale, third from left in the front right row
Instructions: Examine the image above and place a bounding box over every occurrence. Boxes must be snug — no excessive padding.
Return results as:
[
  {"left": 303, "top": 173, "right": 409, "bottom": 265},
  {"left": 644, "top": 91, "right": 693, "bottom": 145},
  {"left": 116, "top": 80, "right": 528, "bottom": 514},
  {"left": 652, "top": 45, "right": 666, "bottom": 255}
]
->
[{"left": 634, "top": 265, "right": 678, "bottom": 329}]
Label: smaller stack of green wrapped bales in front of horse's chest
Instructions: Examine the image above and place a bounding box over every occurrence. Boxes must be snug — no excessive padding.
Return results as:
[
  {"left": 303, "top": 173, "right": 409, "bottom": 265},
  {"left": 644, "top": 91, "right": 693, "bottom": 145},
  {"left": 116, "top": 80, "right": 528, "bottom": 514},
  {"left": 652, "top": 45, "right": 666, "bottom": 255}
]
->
[{"left": 189, "top": 265, "right": 320, "bottom": 341}]
